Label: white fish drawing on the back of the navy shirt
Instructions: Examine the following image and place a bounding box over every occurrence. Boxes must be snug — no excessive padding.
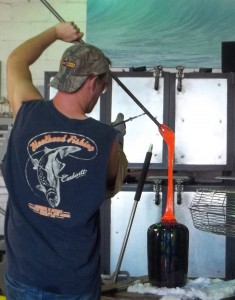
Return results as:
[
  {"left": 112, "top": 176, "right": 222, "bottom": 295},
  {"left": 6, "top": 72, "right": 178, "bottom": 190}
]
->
[{"left": 31, "top": 146, "right": 81, "bottom": 207}]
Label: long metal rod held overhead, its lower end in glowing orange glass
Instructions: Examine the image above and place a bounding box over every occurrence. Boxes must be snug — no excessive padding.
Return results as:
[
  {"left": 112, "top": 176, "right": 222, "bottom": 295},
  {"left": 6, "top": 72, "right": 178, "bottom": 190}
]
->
[{"left": 41, "top": 0, "right": 161, "bottom": 128}]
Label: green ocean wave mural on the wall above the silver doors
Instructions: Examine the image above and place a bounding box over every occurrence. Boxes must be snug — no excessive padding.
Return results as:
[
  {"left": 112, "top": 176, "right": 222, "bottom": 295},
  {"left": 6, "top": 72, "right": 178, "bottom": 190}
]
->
[{"left": 86, "top": 0, "right": 235, "bottom": 69}]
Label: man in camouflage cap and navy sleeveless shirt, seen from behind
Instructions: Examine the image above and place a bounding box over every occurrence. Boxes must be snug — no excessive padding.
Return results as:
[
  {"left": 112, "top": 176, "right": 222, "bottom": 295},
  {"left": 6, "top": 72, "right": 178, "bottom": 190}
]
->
[{"left": 3, "top": 22, "right": 127, "bottom": 300}]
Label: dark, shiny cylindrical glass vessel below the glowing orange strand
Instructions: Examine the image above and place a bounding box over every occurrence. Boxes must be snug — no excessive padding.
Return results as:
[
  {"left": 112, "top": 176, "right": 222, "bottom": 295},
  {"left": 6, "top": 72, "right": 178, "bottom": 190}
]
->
[{"left": 147, "top": 221, "right": 189, "bottom": 288}]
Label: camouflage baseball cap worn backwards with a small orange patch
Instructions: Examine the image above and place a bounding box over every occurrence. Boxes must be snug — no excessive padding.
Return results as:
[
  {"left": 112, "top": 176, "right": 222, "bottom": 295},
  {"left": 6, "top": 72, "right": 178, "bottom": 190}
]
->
[{"left": 50, "top": 43, "right": 110, "bottom": 93}]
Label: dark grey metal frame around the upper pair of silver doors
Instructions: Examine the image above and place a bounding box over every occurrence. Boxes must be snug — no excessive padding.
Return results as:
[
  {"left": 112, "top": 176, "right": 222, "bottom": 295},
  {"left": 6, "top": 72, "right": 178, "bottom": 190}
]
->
[{"left": 44, "top": 71, "right": 235, "bottom": 172}]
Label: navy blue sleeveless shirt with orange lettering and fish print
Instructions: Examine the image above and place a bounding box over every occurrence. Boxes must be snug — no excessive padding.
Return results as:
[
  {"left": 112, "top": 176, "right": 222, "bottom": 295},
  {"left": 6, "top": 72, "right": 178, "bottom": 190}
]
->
[{"left": 3, "top": 100, "right": 116, "bottom": 295}]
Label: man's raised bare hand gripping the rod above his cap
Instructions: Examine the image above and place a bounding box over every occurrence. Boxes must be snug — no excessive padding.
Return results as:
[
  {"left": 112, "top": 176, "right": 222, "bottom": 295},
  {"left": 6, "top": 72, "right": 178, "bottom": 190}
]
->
[{"left": 55, "top": 22, "right": 84, "bottom": 42}]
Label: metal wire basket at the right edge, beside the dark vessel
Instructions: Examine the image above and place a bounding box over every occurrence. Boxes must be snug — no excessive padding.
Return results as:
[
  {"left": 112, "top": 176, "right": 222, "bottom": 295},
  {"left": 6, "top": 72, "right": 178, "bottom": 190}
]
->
[{"left": 189, "top": 189, "right": 235, "bottom": 237}]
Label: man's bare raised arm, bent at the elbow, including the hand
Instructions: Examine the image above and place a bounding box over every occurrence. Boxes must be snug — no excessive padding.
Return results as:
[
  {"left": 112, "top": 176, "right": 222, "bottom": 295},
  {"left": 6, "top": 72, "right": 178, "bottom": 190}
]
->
[{"left": 7, "top": 22, "right": 83, "bottom": 118}]
